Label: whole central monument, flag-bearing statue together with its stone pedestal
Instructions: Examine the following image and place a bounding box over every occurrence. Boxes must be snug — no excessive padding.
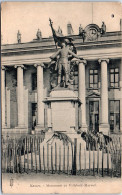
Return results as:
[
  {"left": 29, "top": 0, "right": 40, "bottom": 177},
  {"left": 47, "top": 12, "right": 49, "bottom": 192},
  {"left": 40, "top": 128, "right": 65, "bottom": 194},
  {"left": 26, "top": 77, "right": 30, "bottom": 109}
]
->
[{"left": 44, "top": 20, "right": 85, "bottom": 146}]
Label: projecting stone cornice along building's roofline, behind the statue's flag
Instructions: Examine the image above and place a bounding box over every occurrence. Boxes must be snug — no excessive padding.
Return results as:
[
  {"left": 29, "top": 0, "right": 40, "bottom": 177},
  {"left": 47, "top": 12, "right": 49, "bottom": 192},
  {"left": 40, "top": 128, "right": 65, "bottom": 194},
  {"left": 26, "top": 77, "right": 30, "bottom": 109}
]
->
[{"left": 1, "top": 35, "right": 122, "bottom": 56}]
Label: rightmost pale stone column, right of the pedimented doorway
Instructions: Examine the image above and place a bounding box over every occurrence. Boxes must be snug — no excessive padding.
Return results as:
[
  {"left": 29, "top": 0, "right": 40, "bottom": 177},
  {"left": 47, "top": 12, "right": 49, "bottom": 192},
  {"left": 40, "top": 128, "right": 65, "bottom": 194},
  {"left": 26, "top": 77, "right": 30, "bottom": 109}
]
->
[{"left": 99, "top": 59, "right": 109, "bottom": 135}]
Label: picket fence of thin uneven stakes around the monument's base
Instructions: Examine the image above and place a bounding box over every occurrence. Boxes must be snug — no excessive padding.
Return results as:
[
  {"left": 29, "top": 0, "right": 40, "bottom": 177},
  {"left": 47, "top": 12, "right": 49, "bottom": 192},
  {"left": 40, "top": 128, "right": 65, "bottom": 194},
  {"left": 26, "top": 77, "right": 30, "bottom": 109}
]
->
[{"left": 2, "top": 136, "right": 121, "bottom": 177}]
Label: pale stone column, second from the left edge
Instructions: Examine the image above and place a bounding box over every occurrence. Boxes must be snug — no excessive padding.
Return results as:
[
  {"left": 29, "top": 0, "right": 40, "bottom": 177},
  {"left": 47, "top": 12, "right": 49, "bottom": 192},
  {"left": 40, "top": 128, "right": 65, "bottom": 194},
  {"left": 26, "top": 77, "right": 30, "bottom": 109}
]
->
[{"left": 15, "top": 65, "right": 25, "bottom": 128}]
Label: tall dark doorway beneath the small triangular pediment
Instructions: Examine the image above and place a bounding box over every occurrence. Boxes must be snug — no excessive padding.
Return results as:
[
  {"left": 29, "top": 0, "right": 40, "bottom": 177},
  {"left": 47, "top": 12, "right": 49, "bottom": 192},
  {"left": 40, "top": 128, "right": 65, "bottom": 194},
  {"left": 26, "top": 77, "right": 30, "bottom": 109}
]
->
[{"left": 89, "top": 101, "right": 99, "bottom": 133}]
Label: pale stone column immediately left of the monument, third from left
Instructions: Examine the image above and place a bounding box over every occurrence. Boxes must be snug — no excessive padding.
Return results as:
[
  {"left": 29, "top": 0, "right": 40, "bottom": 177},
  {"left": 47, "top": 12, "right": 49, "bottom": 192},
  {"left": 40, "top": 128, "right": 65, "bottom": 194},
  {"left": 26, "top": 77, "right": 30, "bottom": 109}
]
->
[{"left": 34, "top": 63, "right": 44, "bottom": 131}]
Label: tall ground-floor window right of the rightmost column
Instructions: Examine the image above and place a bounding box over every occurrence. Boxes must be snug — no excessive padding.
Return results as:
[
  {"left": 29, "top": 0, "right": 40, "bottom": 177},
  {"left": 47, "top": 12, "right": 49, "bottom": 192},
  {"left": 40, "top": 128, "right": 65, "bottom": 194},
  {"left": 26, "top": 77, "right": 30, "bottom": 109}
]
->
[{"left": 110, "top": 100, "right": 120, "bottom": 133}]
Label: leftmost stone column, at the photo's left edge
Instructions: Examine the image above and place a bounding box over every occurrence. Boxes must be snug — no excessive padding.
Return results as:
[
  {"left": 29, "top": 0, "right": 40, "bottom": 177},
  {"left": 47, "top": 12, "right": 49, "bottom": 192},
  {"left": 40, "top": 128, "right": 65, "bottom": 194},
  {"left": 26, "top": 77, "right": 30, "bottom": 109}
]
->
[{"left": 1, "top": 66, "right": 6, "bottom": 128}]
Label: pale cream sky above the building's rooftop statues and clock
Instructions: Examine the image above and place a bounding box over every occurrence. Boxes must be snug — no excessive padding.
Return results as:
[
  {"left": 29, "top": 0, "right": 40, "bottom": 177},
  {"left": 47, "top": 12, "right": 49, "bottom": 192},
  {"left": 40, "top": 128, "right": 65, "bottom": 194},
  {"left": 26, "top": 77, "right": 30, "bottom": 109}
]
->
[{"left": 1, "top": 2, "right": 122, "bottom": 44}]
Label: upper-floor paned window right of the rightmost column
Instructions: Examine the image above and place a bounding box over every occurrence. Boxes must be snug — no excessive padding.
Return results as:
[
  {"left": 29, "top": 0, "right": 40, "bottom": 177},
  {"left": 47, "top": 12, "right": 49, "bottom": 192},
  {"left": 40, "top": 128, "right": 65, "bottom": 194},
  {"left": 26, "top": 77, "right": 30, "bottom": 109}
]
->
[{"left": 110, "top": 68, "right": 119, "bottom": 88}]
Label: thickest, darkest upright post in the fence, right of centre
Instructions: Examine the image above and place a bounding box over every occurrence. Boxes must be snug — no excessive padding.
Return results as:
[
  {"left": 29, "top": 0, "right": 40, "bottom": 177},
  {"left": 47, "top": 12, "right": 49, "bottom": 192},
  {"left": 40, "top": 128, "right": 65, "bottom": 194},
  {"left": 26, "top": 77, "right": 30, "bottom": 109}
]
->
[{"left": 72, "top": 138, "right": 77, "bottom": 175}]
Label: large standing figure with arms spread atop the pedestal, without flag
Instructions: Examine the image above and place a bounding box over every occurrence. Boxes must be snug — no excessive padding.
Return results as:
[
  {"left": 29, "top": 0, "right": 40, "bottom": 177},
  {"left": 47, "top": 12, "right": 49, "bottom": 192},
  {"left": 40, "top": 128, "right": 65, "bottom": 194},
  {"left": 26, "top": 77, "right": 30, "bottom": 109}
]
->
[{"left": 50, "top": 42, "right": 80, "bottom": 87}]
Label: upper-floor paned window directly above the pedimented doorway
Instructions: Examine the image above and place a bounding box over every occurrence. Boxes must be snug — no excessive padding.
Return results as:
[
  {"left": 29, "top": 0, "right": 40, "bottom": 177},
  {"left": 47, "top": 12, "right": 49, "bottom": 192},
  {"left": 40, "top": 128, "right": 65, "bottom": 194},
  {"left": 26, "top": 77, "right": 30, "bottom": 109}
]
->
[{"left": 89, "top": 70, "right": 98, "bottom": 88}]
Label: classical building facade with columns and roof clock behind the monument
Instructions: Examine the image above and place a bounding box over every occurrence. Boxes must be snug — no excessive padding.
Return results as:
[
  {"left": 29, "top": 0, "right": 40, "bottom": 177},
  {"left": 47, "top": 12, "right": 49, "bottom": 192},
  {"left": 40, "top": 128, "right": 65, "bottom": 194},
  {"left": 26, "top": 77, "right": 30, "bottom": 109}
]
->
[{"left": 1, "top": 21, "right": 122, "bottom": 137}]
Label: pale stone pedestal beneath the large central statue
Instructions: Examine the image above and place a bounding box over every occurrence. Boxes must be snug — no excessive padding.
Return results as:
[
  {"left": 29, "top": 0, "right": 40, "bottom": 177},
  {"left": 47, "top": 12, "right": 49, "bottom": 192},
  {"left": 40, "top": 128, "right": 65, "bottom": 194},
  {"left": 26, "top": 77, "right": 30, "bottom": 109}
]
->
[{"left": 44, "top": 87, "right": 85, "bottom": 145}]
